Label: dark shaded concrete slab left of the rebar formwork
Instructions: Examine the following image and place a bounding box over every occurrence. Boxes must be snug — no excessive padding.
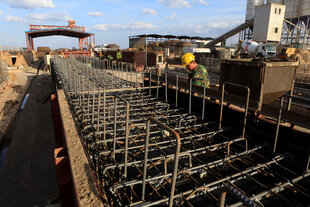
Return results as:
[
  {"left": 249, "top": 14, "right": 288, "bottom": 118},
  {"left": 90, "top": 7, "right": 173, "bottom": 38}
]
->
[{"left": 0, "top": 73, "right": 58, "bottom": 206}]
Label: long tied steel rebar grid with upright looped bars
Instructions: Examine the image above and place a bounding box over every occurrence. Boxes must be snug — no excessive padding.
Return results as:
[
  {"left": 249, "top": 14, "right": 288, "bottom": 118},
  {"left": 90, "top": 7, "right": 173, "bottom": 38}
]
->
[{"left": 52, "top": 57, "right": 310, "bottom": 206}]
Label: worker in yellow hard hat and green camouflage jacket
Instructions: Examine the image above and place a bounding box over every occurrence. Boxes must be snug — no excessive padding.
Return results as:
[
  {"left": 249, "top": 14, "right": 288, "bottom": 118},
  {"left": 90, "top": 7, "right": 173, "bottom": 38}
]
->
[{"left": 181, "top": 53, "right": 210, "bottom": 88}]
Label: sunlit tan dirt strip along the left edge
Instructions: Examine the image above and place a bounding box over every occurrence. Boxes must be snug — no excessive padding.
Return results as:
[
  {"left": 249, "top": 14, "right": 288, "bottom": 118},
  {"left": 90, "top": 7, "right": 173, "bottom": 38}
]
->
[{"left": 0, "top": 68, "right": 37, "bottom": 142}]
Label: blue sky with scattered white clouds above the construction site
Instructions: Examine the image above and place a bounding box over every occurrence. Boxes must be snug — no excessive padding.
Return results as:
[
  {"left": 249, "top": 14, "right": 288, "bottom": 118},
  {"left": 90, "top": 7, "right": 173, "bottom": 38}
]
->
[{"left": 0, "top": 0, "right": 246, "bottom": 49}]
